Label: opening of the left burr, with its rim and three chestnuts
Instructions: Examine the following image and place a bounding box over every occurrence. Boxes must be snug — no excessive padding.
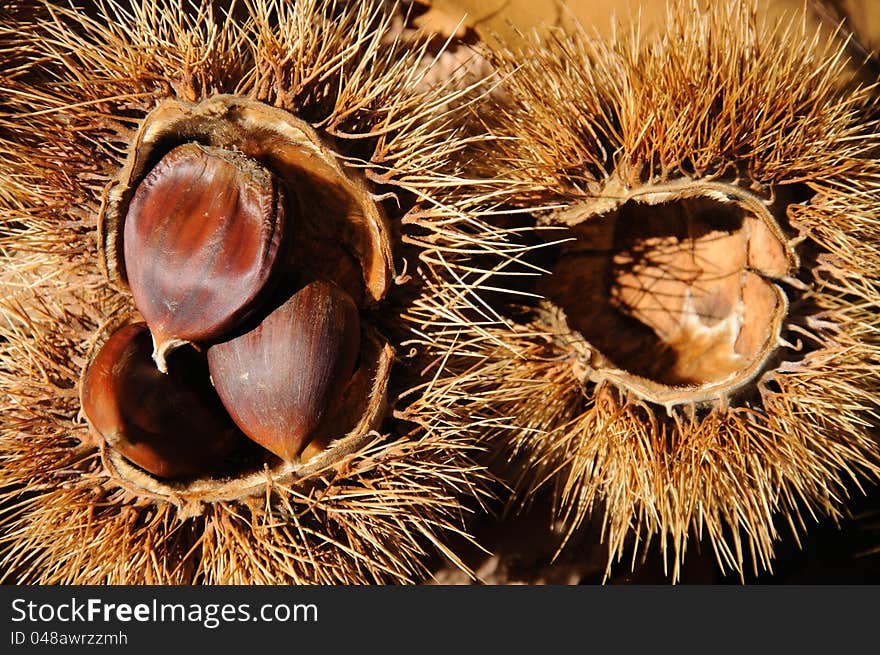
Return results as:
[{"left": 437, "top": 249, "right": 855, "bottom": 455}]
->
[{"left": 81, "top": 96, "right": 392, "bottom": 500}]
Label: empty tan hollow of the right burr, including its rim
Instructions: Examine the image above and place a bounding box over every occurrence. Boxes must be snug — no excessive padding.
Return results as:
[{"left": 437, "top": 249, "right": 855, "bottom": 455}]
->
[{"left": 539, "top": 179, "right": 799, "bottom": 408}]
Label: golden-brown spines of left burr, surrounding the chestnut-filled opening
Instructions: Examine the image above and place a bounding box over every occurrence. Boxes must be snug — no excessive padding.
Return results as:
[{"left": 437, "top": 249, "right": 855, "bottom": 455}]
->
[{"left": 0, "top": 0, "right": 492, "bottom": 584}]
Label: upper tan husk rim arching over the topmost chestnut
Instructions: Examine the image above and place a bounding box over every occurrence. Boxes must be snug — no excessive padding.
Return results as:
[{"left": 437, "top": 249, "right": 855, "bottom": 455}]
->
[{"left": 98, "top": 95, "right": 393, "bottom": 302}]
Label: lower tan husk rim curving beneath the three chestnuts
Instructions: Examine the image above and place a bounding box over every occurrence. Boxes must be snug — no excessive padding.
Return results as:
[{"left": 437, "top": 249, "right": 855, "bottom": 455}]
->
[{"left": 79, "top": 315, "right": 394, "bottom": 514}]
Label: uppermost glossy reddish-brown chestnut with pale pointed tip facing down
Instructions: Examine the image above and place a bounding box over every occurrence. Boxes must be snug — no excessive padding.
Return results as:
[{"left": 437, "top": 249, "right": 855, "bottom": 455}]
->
[{"left": 123, "top": 143, "right": 286, "bottom": 372}]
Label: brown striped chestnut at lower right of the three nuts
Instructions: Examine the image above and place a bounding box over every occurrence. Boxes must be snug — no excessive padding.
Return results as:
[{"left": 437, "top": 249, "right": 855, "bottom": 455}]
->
[{"left": 208, "top": 281, "right": 360, "bottom": 462}]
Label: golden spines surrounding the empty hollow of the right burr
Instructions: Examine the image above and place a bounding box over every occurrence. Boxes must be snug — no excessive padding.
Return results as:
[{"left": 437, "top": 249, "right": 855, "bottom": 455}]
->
[{"left": 404, "top": 1, "right": 880, "bottom": 580}]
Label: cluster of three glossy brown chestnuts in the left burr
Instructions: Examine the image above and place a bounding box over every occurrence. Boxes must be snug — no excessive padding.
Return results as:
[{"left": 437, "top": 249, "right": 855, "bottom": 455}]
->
[{"left": 82, "top": 142, "right": 361, "bottom": 478}]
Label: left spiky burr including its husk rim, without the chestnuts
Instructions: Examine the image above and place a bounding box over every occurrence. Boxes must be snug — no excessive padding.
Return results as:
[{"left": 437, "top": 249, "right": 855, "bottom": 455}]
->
[{"left": 0, "top": 0, "right": 496, "bottom": 584}]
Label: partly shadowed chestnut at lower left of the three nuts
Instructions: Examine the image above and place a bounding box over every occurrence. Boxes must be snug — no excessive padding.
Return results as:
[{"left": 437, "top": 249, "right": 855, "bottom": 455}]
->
[{"left": 81, "top": 323, "right": 247, "bottom": 478}]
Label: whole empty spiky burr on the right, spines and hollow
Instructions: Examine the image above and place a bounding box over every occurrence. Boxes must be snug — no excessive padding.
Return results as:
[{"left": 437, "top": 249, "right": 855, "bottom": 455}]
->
[{"left": 404, "top": 2, "right": 880, "bottom": 580}]
